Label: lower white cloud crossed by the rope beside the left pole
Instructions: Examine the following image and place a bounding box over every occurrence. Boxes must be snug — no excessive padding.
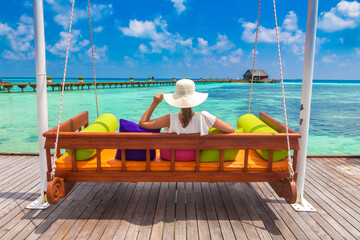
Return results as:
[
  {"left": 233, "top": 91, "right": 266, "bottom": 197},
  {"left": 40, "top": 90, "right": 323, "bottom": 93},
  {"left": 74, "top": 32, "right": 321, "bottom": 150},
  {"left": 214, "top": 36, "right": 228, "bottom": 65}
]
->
[{"left": 47, "top": 29, "right": 89, "bottom": 56}]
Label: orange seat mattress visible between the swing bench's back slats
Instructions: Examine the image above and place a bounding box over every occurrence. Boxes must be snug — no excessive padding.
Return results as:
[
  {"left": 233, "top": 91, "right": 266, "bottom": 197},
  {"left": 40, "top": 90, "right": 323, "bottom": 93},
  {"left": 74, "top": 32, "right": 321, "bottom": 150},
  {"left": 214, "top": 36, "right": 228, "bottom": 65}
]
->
[{"left": 56, "top": 149, "right": 288, "bottom": 172}]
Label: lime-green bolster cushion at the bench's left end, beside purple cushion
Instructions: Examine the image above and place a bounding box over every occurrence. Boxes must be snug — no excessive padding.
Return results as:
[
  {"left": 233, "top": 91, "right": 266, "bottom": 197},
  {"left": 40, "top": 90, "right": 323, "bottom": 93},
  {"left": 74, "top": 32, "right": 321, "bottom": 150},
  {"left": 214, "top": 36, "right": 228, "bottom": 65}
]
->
[{"left": 66, "top": 113, "right": 118, "bottom": 161}]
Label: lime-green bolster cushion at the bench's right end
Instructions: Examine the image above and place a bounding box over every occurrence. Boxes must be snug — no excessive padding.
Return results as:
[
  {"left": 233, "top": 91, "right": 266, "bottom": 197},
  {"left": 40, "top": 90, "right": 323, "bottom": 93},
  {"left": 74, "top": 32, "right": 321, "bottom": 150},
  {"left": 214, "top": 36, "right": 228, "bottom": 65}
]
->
[{"left": 237, "top": 114, "right": 288, "bottom": 162}]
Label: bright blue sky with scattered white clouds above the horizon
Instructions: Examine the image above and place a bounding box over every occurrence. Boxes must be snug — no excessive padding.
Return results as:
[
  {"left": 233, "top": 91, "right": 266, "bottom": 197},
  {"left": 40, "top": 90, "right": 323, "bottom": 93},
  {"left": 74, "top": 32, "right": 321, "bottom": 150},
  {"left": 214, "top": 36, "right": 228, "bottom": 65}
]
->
[{"left": 0, "top": 0, "right": 360, "bottom": 80}]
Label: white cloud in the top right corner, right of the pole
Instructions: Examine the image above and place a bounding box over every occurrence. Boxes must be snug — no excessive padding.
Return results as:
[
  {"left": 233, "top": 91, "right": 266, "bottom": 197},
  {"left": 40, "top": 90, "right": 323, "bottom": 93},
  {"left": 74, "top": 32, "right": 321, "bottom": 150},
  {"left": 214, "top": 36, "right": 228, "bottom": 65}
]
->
[{"left": 318, "top": 0, "right": 360, "bottom": 32}]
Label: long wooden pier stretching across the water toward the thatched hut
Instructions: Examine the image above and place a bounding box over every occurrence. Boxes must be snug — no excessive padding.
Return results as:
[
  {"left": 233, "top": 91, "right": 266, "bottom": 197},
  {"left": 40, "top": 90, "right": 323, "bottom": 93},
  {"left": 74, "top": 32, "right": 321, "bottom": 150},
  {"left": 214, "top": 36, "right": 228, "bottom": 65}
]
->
[{"left": 0, "top": 79, "right": 279, "bottom": 93}]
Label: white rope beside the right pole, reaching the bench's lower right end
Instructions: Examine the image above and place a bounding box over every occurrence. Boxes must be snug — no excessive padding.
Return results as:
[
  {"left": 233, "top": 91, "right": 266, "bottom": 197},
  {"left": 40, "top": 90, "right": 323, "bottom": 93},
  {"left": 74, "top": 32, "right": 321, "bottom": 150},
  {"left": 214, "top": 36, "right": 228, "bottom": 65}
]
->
[{"left": 273, "top": 0, "right": 294, "bottom": 179}]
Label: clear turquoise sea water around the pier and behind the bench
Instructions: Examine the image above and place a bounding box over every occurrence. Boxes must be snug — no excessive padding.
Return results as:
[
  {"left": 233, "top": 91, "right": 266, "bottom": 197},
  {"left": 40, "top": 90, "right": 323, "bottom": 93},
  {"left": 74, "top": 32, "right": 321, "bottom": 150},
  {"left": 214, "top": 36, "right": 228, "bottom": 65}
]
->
[{"left": 0, "top": 79, "right": 360, "bottom": 154}]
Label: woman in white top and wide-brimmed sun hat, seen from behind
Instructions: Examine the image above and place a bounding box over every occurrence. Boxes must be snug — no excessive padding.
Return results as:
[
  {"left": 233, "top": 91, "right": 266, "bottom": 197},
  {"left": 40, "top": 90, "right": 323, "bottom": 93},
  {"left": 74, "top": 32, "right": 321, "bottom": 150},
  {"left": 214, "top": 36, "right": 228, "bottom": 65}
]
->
[{"left": 139, "top": 79, "right": 235, "bottom": 136}]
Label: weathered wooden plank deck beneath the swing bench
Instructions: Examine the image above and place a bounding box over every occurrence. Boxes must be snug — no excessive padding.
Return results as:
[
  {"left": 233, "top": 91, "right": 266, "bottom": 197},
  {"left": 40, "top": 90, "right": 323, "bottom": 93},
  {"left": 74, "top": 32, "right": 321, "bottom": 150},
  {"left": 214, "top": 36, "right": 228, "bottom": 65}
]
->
[{"left": 0, "top": 156, "right": 360, "bottom": 240}]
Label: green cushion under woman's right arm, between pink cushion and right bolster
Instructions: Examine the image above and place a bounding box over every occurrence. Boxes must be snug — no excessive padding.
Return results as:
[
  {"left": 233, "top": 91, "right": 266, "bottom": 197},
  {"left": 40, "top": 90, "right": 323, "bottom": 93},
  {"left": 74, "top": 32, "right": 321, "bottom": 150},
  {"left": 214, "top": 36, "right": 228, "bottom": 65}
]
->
[{"left": 200, "top": 127, "right": 243, "bottom": 162}]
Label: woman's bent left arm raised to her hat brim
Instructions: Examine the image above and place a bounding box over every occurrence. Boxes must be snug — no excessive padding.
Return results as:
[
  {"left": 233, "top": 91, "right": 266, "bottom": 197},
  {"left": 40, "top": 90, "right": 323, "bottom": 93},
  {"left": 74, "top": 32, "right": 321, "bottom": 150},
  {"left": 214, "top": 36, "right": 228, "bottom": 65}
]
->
[{"left": 139, "top": 93, "right": 170, "bottom": 129}]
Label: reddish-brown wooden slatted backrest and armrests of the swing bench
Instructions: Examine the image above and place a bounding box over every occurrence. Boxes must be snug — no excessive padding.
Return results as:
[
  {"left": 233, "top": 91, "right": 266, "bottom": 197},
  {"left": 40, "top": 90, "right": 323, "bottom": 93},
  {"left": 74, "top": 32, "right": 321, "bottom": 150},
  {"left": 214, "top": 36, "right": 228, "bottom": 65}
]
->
[{"left": 44, "top": 111, "right": 301, "bottom": 181}]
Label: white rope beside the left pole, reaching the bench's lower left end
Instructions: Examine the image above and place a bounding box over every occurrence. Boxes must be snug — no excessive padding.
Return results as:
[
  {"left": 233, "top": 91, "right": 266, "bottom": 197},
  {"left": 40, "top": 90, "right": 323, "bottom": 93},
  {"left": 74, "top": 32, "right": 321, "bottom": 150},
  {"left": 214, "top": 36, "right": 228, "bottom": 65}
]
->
[{"left": 51, "top": 0, "right": 75, "bottom": 179}]
